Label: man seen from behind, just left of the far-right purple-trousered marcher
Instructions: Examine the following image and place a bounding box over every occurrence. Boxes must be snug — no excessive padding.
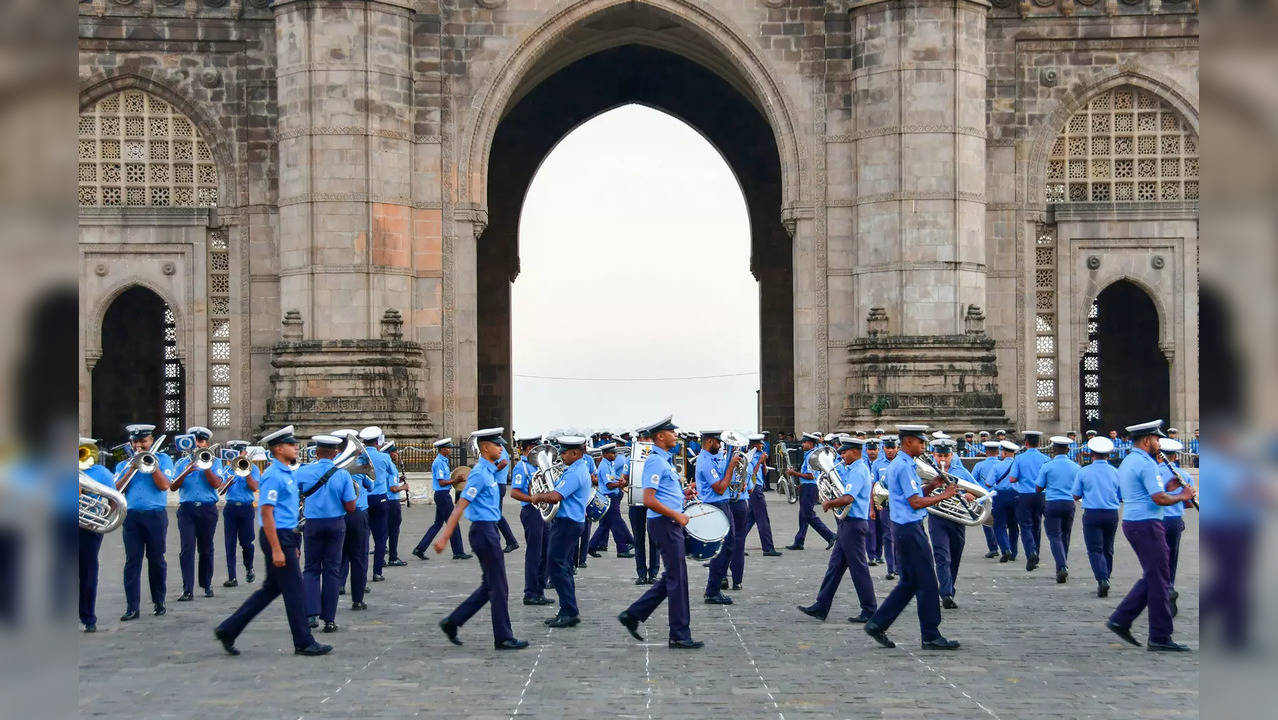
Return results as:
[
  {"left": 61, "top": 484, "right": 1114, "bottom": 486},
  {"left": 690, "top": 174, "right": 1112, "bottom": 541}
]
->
[{"left": 1070, "top": 436, "right": 1121, "bottom": 597}]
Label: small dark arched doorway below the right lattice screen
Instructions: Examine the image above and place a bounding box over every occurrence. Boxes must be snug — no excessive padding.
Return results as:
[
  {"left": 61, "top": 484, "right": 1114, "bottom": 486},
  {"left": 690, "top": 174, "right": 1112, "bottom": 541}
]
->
[{"left": 1079, "top": 280, "right": 1171, "bottom": 434}]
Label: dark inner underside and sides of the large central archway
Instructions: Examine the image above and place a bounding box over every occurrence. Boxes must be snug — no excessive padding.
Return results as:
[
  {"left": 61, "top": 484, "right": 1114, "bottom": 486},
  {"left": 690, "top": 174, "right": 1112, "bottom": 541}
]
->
[{"left": 477, "top": 32, "right": 795, "bottom": 430}]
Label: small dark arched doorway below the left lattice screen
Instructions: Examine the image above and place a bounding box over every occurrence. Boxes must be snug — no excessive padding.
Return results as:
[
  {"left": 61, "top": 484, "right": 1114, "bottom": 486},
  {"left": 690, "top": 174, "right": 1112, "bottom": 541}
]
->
[{"left": 93, "top": 286, "right": 185, "bottom": 445}]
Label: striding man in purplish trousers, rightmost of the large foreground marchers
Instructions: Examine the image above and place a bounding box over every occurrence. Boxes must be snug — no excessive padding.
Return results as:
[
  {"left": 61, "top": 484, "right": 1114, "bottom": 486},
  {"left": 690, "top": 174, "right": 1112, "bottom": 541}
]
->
[{"left": 1105, "top": 419, "right": 1196, "bottom": 652}]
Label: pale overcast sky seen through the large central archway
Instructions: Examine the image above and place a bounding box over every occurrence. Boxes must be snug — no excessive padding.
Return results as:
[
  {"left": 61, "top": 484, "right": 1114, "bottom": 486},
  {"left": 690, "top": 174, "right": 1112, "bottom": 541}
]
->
[{"left": 511, "top": 105, "right": 759, "bottom": 432}]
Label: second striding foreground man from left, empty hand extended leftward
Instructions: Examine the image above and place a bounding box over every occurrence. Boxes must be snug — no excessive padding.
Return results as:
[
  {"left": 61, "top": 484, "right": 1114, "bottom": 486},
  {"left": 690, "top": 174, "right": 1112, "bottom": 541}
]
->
[{"left": 433, "top": 427, "right": 528, "bottom": 650}]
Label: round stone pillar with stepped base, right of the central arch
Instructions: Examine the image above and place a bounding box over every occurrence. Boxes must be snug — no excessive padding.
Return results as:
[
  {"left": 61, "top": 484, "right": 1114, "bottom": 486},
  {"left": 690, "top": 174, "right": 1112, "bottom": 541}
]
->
[{"left": 840, "top": 0, "right": 1003, "bottom": 427}]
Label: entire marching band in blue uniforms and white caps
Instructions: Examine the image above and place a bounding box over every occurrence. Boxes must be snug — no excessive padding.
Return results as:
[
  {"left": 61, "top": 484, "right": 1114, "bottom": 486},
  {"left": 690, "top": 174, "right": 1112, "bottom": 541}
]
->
[{"left": 79, "top": 417, "right": 1196, "bottom": 655}]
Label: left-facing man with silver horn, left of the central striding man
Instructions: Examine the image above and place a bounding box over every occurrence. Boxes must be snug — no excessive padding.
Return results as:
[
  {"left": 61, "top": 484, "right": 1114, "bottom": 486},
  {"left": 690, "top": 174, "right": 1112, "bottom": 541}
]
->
[{"left": 532, "top": 435, "right": 590, "bottom": 628}]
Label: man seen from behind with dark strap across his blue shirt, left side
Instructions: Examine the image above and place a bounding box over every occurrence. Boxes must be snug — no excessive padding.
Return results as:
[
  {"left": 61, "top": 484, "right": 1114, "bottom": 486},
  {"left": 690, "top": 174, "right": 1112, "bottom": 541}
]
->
[{"left": 293, "top": 435, "right": 355, "bottom": 633}]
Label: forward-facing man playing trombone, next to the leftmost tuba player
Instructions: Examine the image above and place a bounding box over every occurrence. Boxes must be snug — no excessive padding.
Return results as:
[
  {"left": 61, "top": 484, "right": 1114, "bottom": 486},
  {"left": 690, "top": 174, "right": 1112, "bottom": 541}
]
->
[{"left": 115, "top": 425, "right": 173, "bottom": 622}]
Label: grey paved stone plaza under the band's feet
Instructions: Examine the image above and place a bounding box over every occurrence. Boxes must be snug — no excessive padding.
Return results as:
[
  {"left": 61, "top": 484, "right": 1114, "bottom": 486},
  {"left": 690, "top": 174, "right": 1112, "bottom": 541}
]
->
[{"left": 79, "top": 495, "right": 1199, "bottom": 720}]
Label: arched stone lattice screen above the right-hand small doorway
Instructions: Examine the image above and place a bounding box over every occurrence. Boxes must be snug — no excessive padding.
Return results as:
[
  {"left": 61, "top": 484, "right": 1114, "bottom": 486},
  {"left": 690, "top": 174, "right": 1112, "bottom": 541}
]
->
[{"left": 1047, "top": 87, "right": 1199, "bottom": 203}]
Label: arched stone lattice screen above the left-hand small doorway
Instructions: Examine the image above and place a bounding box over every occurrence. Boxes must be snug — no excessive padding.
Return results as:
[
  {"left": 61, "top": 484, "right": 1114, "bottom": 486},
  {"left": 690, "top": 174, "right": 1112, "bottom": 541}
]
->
[{"left": 77, "top": 90, "right": 217, "bottom": 207}]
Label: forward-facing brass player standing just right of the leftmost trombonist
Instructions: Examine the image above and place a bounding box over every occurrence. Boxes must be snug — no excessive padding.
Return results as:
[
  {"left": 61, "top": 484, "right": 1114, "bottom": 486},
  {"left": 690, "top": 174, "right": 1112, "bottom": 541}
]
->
[{"left": 169, "top": 426, "right": 222, "bottom": 602}]
